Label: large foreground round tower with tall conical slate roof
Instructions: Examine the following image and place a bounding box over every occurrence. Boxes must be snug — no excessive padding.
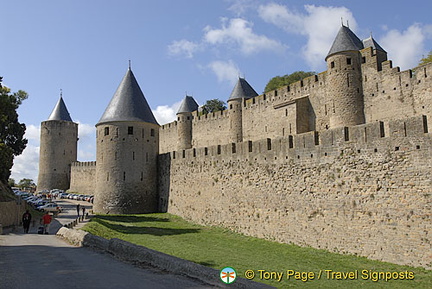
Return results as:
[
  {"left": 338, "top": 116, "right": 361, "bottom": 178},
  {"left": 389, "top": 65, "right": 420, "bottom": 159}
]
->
[{"left": 94, "top": 68, "right": 159, "bottom": 214}]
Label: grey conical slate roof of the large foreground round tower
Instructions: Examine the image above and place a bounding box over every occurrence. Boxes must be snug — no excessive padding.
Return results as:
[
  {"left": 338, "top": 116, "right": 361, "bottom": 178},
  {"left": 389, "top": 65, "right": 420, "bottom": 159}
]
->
[{"left": 98, "top": 68, "right": 158, "bottom": 124}]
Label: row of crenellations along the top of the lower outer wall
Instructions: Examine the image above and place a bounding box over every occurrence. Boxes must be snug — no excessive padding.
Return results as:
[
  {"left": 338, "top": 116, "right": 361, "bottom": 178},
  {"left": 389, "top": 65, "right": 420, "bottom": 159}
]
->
[{"left": 165, "top": 116, "right": 431, "bottom": 163}]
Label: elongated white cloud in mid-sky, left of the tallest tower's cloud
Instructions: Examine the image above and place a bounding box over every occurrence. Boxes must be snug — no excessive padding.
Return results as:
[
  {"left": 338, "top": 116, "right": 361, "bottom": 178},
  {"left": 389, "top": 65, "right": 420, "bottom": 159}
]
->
[{"left": 204, "top": 18, "right": 285, "bottom": 55}]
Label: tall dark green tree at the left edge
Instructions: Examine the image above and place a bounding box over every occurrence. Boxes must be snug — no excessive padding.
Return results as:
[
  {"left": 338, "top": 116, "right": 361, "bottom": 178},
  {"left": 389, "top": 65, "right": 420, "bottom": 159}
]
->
[{"left": 0, "top": 83, "right": 28, "bottom": 183}]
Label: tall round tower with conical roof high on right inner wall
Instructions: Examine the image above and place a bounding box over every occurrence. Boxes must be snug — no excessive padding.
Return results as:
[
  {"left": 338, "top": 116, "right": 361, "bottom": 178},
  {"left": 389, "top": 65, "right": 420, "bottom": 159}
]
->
[{"left": 326, "top": 25, "right": 365, "bottom": 128}]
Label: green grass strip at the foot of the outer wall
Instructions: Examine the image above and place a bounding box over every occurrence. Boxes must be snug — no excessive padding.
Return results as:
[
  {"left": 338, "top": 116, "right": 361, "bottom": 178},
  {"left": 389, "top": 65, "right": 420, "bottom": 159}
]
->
[{"left": 83, "top": 213, "right": 432, "bottom": 288}]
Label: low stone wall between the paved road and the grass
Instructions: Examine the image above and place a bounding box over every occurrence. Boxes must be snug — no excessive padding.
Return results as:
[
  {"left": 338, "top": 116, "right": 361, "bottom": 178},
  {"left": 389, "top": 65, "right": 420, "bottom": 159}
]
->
[{"left": 57, "top": 227, "right": 273, "bottom": 289}]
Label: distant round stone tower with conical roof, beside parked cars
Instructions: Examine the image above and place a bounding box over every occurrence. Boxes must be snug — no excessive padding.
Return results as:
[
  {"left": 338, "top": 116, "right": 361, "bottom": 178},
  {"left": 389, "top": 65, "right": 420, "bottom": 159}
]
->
[{"left": 37, "top": 96, "right": 78, "bottom": 191}]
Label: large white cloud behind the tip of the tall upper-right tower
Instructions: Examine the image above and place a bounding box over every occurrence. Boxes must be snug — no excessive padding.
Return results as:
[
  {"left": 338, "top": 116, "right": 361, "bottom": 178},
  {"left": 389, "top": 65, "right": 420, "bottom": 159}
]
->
[{"left": 258, "top": 3, "right": 357, "bottom": 69}]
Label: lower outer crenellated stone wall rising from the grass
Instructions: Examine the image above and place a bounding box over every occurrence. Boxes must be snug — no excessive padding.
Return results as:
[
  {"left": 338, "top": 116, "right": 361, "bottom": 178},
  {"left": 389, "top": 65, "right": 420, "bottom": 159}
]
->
[{"left": 159, "top": 116, "right": 432, "bottom": 268}]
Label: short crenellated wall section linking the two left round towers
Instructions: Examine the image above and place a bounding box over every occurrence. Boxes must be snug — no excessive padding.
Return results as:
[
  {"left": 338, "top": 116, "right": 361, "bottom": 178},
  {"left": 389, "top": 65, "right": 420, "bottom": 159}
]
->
[{"left": 69, "top": 162, "right": 96, "bottom": 195}]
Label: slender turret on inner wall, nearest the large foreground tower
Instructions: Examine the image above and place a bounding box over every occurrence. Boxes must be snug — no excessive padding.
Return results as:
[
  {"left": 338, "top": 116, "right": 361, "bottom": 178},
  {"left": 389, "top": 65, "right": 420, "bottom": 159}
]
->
[{"left": 177, "top": 95, "right": 198, "bottom": 150}]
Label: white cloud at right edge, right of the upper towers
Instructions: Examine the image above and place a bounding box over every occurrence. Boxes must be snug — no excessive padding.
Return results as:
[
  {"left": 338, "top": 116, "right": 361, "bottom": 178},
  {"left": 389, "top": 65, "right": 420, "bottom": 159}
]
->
[{"left": 380, "top": 24, "right": 431, "bottom": 69}]
